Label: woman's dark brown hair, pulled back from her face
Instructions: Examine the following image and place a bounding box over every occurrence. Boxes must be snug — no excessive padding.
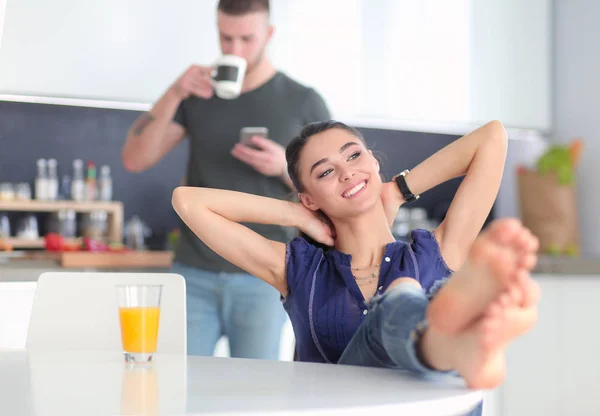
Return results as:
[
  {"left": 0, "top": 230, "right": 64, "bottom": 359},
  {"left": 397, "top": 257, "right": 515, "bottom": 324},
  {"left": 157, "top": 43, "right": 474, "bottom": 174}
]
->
[{"left": 285, "top": 120, "right": 366, "bottom": 250}]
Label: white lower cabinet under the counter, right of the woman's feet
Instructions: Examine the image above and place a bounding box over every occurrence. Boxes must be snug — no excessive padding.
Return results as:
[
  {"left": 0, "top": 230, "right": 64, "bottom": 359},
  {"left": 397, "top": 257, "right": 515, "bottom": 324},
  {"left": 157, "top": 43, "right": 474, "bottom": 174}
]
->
[{"left": 498, "top": 274, "right": 600, "bottom": 416}]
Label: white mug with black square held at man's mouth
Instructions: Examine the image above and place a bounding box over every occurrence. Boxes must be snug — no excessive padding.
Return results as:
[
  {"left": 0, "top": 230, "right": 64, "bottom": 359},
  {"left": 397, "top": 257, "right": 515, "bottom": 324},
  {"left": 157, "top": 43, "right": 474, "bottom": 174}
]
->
[{"left": 212, "top": 55, "right": 246, "bottom": 100}]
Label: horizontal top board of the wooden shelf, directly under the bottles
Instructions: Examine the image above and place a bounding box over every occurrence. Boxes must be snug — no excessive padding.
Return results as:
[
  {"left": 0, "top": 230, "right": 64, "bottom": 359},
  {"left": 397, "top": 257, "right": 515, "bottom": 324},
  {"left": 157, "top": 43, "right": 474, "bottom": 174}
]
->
[{"left": 0, "top": 200, "right": 123, "bottom": 212}]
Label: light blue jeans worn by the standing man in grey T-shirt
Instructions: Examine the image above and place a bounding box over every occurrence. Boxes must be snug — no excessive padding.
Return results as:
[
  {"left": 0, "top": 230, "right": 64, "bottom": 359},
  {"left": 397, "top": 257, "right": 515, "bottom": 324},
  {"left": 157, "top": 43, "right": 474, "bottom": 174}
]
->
[{"left": 171, "top": 263, "right": 285, "bottom": 360}]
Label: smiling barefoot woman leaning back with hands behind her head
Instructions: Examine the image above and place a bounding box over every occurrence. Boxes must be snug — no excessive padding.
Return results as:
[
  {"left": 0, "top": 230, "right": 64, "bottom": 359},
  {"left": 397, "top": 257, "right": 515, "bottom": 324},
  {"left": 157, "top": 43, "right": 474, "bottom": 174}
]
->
[{"left": 173, "top": 121, "right": 537, "bottom": 394}]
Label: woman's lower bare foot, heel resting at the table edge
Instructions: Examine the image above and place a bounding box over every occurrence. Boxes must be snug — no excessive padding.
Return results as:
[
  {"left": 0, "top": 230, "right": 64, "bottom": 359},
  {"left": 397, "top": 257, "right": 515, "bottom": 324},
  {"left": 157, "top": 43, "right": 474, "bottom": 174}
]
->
[{"left": 421, "top": 277, "right": 539, "bottom": 389}]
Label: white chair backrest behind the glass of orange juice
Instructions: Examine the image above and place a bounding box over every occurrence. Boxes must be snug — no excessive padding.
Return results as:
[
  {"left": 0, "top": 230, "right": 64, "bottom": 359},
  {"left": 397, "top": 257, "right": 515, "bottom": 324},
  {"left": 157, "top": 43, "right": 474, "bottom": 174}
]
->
[{"left": 26, "top": 272, "right": 187, "bottom": 354}]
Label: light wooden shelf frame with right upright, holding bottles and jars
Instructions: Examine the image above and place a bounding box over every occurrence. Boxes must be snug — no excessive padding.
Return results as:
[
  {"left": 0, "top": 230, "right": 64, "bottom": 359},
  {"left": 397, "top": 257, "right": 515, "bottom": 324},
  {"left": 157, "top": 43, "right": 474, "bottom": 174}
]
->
[{"left": 0, "top": 200, "right": 123, "bottom": 242}]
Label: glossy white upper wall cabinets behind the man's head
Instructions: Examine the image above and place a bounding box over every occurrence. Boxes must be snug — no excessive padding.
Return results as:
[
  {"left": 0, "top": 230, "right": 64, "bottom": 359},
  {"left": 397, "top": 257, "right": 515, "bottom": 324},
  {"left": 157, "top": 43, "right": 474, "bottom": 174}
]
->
[{"left": 0, "top": 0, "right": 553, "bottom": 132}]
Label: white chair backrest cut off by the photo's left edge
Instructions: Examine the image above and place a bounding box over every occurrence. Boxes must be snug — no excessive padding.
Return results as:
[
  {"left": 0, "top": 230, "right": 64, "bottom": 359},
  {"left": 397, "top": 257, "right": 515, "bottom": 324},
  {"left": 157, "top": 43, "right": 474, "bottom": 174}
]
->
[{"left": 0, "top": 282, "right": 36, "bottom": 348}]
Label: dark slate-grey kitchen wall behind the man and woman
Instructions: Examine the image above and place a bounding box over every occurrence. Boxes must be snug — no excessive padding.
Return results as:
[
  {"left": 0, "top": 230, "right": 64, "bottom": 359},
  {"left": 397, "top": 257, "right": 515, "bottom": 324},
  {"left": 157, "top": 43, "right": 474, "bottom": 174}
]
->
[{"left": 0, "top": 102, "right": 480, "bottom": 245}]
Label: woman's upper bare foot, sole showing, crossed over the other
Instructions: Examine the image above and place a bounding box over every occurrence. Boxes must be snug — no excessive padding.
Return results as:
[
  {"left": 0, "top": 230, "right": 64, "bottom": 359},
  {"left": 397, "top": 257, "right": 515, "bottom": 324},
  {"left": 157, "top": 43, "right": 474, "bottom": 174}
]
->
[{"left": 427, "top": 219, "right": 538, "bottom": 334}]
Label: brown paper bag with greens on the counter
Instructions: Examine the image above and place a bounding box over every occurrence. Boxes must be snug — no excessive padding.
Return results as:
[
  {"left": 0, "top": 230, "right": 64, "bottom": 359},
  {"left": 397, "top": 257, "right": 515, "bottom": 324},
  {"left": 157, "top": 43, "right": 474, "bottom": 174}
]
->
[{"left": 517, "top": 169, "right": 579, "bottom": 256}]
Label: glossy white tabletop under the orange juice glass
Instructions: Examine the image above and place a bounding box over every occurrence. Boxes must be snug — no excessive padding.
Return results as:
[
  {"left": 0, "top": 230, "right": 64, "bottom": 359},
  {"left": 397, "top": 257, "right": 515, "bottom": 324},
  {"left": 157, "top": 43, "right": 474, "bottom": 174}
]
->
[{"left": 0, "top": 350, "right": 482, "bottom": 416}]
